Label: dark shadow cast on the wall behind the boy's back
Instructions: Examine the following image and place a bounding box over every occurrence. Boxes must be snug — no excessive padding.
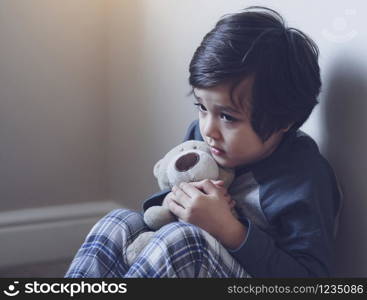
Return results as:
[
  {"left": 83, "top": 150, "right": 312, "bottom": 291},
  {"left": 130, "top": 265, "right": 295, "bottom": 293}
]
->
[{"left": 323, "top": 55, "right": 367, "bottom": 277}]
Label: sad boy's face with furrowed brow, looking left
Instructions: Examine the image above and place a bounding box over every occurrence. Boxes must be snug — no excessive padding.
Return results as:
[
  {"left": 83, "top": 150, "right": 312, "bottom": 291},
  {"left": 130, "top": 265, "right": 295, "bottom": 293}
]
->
[{"left": 194, "top": 77, "right": 287, "bottom": 168}]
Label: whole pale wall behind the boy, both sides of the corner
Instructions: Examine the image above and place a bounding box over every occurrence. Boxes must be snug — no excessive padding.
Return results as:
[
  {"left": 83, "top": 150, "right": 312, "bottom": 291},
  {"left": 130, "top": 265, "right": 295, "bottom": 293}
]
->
[{"left": 0, "top": 0, "right": 367, "bottom": 276}]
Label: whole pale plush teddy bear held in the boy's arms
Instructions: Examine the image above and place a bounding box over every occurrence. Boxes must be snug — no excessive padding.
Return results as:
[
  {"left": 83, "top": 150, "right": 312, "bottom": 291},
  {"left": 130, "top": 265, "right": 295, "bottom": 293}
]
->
[{"left": 126, "top": 140, "right": 235, "bottom": 265}]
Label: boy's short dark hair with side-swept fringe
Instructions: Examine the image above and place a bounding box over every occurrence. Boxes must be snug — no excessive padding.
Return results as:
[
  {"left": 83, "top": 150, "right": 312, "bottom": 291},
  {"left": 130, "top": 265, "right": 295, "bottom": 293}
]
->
[{"left": 189, "top": 6, "right": 321, "bottom": 141}]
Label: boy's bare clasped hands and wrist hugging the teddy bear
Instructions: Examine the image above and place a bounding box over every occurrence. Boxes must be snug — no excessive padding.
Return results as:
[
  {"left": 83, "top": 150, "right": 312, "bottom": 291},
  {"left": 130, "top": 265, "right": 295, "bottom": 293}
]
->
[{"left": 165, "top": 179, "right": 245, "bottom": 248}]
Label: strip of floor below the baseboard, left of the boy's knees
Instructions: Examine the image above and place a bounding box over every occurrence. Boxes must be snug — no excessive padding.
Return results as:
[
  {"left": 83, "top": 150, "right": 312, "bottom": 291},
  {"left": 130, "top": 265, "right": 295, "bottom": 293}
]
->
[{"left": 0, "top": 259, "right": 71, "bottom": 278}]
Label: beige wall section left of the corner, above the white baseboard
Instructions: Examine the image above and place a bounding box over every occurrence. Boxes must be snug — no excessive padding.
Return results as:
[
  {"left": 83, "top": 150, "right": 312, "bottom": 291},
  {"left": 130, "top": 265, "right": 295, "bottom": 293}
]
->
[{"left": 0, "top": 0, "right": 108, "bottom": 211}]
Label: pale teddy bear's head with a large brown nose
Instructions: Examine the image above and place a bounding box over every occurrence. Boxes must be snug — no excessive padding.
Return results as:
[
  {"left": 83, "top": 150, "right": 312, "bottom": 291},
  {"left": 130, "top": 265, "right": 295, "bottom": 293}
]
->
[{"left": 153, "top": 140, "right": 234, "bottom": 190}]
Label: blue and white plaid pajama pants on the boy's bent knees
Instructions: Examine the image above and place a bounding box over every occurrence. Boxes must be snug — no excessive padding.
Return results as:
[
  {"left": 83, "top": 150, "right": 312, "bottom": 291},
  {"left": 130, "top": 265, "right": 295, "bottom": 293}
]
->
[{"left": 65, "top": 209, "right": 250, "bottom": 278}]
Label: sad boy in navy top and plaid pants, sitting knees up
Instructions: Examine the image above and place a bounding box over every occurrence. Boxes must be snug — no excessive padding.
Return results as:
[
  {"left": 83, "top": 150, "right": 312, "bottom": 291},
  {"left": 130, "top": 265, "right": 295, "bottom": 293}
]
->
[{"left": 66, "top": 7, "right": 340, "bottom": 277}]
